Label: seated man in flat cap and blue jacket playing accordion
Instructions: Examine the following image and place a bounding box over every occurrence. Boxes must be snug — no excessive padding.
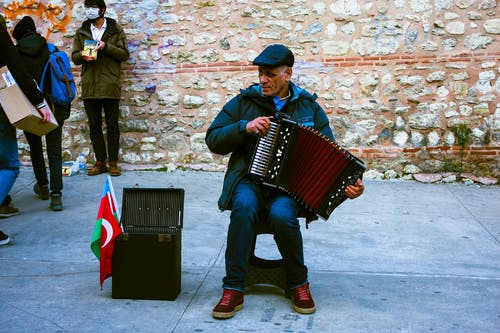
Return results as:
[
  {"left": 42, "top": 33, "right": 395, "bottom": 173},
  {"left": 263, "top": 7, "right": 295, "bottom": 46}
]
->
[{"left": 205, "top": 44, "right": 364, "bottom": 319}]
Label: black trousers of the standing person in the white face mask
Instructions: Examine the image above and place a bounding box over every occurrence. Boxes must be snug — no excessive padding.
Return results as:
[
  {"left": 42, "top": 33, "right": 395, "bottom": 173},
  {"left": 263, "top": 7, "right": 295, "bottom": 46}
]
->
[{"left": 83, "top": 98, "right": 120, "bottom": 162}]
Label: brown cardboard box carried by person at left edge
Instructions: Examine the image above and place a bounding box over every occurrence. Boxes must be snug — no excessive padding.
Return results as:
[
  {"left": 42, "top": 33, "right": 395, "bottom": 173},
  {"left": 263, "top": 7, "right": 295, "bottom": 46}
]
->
[{"left": 0, "top": 66, "right": 59, "bottom": 136}]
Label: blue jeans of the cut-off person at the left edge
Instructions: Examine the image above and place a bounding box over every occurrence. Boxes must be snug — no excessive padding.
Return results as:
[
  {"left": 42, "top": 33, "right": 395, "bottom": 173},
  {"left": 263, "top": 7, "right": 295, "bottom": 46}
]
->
[{"left": 0, "top": 107, "right": 20, "bottom": 202}]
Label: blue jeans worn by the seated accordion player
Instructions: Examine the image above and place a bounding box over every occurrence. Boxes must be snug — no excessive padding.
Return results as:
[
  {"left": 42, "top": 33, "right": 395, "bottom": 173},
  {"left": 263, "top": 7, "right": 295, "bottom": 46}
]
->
[{"left": 223, "top": 178, "right": 307, "bottom": 291}]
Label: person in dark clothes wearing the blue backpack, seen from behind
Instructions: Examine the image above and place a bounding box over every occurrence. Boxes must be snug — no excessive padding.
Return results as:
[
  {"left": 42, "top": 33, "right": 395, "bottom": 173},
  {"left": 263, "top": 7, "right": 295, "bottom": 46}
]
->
[{"left": 12, "top": 16, "right": 71, "bottom": 211}]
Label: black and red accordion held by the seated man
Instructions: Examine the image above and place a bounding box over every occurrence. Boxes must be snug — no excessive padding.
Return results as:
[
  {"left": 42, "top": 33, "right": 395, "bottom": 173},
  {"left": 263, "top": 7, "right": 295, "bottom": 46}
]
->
[{"left": 248, "top": 118, "right": 366, "bottom": 220}]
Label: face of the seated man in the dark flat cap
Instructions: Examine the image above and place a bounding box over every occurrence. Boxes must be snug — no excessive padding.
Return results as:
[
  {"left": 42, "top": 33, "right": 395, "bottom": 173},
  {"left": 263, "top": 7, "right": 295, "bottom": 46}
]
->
[{"left": 259, "top": 66, "right": 292, "bottom": 97}]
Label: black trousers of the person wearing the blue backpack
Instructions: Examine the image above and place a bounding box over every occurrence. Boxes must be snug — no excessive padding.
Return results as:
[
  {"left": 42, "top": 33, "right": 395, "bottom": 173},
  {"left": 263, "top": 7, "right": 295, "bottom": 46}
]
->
[{"left": 24, "top": 120, "right": 64, "bottom": 194}]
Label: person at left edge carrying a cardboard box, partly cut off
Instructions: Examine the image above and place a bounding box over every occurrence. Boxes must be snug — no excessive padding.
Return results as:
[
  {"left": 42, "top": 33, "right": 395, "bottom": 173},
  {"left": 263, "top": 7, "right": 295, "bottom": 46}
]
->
[{"left": 0, "top": 15, "right": 51, "bottom": 245}]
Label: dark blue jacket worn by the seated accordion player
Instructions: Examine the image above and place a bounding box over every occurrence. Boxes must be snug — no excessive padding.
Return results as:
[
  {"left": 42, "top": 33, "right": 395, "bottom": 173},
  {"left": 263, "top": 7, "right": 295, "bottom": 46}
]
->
[{"left": 205, "top": 82, "right": 334, "bottom": 210}]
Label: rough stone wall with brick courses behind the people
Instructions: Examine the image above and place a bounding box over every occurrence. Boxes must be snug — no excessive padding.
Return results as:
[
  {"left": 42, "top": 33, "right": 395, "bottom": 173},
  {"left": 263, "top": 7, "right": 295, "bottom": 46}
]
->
[{"left": 2, "top": 0, "right": 500, "bottom": 177}]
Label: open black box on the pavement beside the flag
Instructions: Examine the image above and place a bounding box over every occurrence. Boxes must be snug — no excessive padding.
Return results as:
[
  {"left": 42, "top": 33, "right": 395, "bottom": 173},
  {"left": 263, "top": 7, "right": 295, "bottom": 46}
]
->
[{"left": 112, "top": 188, "right": 184, "bottom": 300}]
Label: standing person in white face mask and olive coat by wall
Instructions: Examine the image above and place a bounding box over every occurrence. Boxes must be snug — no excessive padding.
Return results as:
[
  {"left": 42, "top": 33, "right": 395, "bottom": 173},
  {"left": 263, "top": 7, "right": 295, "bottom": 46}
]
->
[{"left": 72, "top": 0, "right": 129, "bottom": 176}]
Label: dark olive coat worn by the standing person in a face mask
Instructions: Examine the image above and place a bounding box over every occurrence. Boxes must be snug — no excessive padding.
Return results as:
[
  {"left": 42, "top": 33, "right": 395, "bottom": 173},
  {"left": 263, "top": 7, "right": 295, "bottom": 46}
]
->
[{"left": 71, "top": 17, "right": 130, "bottom": 99}]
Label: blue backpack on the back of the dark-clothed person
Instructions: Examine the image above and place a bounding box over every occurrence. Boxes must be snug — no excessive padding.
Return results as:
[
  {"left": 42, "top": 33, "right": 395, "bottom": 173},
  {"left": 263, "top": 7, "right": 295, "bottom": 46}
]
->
[{"left": 40, "top": 43, "right": 76, "bottom": 105}]
